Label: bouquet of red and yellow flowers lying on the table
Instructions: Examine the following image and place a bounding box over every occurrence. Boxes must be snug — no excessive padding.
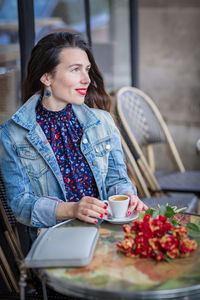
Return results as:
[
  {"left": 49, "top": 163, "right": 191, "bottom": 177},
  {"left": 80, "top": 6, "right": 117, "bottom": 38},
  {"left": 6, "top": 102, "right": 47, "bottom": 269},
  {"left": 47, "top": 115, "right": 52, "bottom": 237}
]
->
[{"left": 116, "top": 205, "right": 199, "bottom": 261}]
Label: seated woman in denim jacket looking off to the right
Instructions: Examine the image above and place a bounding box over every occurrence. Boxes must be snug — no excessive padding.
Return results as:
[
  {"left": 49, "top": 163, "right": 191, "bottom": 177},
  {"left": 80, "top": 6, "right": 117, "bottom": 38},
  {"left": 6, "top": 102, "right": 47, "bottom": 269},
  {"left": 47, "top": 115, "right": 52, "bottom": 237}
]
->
[{"left": 0, "top": 32, "right": 147, "bottom": 239}]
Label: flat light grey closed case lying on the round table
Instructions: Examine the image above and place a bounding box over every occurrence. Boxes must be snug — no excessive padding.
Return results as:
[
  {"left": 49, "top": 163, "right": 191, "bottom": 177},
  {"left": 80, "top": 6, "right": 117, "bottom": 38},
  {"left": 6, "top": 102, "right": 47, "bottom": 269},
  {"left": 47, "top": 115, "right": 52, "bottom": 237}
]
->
[{"left": 22, "top": 226, "right": 99, "bottom": 268}]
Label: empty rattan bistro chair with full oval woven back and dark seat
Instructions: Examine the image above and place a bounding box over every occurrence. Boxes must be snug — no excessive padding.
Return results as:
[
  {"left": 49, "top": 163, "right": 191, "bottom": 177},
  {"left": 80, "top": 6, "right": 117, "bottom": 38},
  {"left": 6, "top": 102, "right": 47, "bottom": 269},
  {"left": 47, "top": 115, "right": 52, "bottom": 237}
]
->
[{"left": 116, "top": 87, "right": 200, "bottom": 194}]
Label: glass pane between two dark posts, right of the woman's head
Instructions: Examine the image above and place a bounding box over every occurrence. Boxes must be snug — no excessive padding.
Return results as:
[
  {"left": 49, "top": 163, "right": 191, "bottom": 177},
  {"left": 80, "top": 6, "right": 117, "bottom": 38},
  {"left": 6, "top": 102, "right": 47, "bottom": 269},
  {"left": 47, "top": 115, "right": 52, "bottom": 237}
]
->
[{"left": 90, "top": 0, "right": 131, "bottom": 92}]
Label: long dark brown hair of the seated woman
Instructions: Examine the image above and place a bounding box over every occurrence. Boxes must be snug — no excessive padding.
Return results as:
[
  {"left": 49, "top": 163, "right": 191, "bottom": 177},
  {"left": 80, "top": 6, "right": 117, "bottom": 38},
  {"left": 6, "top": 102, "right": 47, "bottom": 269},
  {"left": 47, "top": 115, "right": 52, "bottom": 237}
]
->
[{"left": 23, "top": 32, "right": 111, "bottom": 111}]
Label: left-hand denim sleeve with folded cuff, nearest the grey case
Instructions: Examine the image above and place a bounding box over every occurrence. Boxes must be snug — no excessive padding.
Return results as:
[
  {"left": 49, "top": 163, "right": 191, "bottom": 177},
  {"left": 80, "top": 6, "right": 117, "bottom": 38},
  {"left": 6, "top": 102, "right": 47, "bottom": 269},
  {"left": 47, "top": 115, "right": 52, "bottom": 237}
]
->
[{"left": 0, "top": 131, "right": 61, "bottom": 227}]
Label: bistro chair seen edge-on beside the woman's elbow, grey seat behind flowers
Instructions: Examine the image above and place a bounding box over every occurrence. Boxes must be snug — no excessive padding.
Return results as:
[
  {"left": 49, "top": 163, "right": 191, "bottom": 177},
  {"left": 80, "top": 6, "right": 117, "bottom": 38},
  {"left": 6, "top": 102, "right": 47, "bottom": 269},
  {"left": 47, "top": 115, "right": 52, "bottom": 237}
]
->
[{"left": 121, "top": 136, "right": 197, "bottom": 213}]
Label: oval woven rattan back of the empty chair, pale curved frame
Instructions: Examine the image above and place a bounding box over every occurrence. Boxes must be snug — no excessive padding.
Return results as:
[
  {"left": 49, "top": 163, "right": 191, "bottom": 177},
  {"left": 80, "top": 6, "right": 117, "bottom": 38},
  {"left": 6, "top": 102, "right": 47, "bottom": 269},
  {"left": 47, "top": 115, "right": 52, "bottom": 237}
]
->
[{"left": 117, "top": 87, "right": 184, "bottom": 172}]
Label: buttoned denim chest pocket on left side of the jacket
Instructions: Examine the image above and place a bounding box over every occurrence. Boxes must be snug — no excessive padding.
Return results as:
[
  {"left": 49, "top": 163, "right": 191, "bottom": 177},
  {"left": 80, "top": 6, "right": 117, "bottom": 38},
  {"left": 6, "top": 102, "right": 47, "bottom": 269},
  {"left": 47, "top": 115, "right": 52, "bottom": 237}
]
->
[{"left": 17, "top": 145, "right": 48, "bottom": 178}]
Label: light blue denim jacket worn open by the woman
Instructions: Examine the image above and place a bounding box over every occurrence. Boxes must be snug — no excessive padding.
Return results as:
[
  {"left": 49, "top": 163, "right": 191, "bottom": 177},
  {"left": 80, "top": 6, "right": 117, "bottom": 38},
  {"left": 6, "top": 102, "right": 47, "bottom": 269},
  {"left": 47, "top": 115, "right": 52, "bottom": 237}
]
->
[{"left": 0, "top": 94, "right": 136, "bottom": 231}]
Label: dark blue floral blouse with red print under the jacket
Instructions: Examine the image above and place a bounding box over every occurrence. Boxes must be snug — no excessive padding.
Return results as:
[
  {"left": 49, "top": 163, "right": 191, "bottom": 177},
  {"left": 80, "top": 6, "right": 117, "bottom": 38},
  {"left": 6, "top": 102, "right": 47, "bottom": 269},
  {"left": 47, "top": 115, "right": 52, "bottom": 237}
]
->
[{"left": 36, "top": 101, "right": 98, "bottom": 202}]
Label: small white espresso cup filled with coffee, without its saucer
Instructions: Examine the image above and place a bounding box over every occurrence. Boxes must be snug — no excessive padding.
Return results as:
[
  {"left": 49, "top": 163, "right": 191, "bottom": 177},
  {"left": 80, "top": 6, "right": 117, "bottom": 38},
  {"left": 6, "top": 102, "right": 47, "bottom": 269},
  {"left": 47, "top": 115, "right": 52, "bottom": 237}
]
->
[{"left": 105, "top": 195, "right": 130, "bottom": 218}]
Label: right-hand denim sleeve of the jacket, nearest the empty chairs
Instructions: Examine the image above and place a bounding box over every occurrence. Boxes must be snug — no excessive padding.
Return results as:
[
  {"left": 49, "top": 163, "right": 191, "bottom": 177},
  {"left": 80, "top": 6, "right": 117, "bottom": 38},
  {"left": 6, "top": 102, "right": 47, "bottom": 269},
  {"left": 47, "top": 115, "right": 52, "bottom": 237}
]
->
[{"left": 105, "top": 122, "right": 137, "bottom": 197}]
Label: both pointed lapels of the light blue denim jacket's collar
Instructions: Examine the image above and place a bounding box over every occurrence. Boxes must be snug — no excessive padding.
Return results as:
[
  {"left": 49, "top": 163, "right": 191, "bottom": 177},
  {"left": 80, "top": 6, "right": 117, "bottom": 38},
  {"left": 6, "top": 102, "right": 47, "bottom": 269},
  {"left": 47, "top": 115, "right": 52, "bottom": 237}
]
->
[{"left": 12, "top": 94, "right": 100, "bottom": 131}]
